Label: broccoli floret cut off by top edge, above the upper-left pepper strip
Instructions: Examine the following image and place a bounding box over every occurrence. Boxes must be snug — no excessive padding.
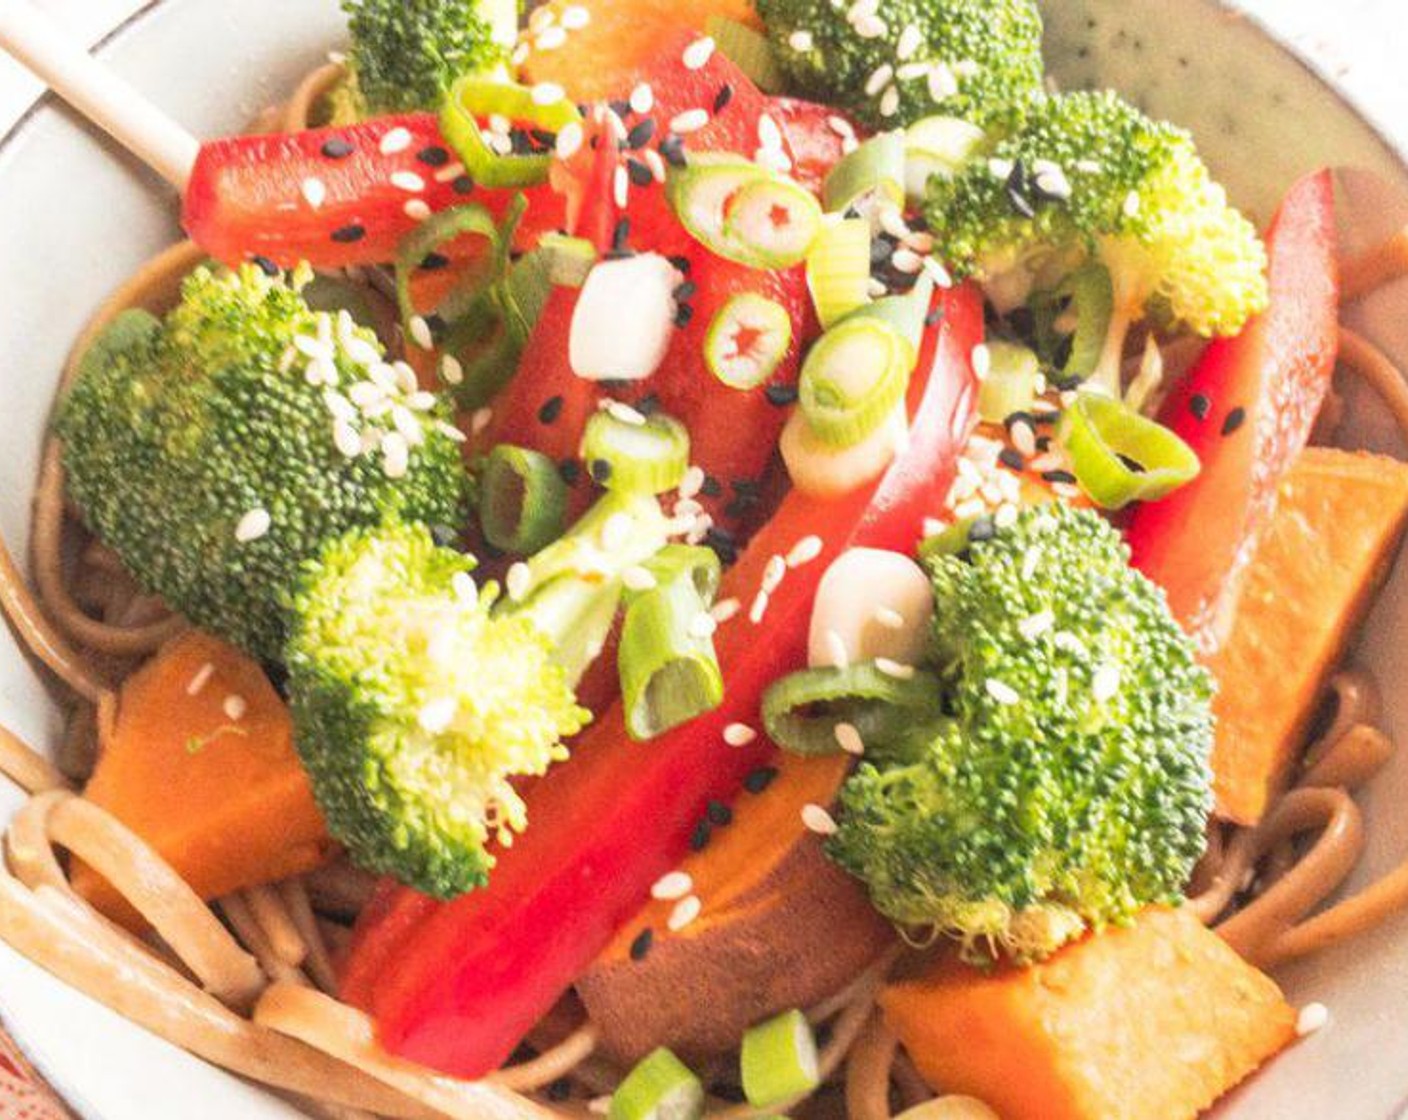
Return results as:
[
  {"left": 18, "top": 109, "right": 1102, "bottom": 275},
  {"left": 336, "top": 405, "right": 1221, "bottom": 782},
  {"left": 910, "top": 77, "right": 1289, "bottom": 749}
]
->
[{"left": 332, "top": 0, "right": 520, "bottom": 121}]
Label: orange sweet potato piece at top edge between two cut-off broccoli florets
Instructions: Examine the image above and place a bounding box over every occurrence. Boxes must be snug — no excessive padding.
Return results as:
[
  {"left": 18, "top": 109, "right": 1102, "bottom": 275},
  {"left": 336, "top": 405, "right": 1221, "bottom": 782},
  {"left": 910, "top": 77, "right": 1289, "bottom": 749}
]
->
[{"left": 524, "top": 0, "right": 758, "bottom": 101}]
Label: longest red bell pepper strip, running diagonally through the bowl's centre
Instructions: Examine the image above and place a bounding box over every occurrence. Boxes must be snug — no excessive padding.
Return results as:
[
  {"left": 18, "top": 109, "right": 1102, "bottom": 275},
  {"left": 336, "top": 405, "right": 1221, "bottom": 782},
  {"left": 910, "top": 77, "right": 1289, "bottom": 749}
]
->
[{"left": 342, "top": 280, "right": 983, "bottom": 1076}]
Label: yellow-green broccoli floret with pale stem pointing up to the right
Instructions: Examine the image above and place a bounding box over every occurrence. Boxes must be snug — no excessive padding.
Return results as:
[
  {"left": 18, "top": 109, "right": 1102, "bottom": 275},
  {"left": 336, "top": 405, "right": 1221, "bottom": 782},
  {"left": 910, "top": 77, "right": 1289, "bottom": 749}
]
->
[{"left": 287, "top": 496, "right": 669, "bottom": 899}]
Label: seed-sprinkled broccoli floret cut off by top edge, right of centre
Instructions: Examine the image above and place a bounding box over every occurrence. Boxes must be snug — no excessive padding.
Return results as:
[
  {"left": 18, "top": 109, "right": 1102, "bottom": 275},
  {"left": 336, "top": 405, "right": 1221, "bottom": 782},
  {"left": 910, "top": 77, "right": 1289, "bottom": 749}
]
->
[{"left": 758, "top": 0, "right": 1042, "bottom": 130}]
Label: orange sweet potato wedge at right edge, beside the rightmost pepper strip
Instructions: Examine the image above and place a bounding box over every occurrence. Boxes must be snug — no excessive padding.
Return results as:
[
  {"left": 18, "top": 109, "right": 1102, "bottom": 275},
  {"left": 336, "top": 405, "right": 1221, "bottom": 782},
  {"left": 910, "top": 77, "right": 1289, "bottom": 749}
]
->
[{"left": 1209, "top": 448, "right": 1408, "bottom": 824}]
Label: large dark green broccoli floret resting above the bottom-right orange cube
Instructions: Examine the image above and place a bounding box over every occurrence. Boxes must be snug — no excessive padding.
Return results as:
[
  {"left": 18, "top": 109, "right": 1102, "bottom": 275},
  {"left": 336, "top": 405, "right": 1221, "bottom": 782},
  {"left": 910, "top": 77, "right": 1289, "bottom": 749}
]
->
[{"left": 829, "top": 506, "right": 1212, "bottom": 962}]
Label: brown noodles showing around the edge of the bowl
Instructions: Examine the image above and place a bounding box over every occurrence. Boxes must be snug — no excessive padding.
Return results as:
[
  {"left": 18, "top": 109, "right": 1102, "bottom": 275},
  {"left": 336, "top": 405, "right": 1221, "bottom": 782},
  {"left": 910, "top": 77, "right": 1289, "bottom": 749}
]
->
[{"left": 0, "top": 74, "right": 1408, "bottom": 1120}]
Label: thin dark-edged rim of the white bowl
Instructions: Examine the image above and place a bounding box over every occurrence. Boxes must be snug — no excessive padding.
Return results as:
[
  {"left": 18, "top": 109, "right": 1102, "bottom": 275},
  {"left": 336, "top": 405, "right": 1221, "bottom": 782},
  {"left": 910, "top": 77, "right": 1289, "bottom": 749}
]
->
[{"left": 0, "top": 0, "right": 1408, "bottom": 1120}]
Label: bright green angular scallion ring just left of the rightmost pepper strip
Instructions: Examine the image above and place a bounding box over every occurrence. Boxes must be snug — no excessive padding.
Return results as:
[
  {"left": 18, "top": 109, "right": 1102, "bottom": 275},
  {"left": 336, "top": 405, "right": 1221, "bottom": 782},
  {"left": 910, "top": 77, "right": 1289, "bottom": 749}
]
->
[{"left": 1056, "top": 393, "right": 1201, "bottom": 510}]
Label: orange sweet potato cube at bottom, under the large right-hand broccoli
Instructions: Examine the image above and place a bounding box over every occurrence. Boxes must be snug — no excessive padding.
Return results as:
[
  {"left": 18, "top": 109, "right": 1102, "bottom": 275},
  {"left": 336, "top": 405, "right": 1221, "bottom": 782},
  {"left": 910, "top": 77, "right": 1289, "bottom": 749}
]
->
[{"left": 880, "top": 909, "right": 1295, "bottom": 1120}]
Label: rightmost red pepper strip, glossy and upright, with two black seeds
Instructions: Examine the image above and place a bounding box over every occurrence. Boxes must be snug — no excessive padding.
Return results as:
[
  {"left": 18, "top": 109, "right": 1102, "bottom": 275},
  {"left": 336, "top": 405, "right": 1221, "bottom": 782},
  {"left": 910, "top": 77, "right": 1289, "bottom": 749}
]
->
[{"left": 1128, "top": 170, "right": 1339, "bottom": 654}]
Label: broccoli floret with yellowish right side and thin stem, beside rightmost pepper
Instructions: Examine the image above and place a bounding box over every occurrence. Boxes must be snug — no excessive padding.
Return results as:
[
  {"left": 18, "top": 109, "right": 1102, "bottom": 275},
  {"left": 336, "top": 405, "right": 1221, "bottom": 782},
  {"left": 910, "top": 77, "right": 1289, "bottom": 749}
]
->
[{"left": 926, "top": 90, "right": 1267, "bottom": 392}]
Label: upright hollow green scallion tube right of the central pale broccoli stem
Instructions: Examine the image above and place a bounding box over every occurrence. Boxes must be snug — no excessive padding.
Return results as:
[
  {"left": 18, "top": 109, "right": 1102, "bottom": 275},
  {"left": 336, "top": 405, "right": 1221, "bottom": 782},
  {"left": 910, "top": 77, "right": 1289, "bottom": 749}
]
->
[{"left": 618, "top": 548, "right": 724, "bottom": 740}]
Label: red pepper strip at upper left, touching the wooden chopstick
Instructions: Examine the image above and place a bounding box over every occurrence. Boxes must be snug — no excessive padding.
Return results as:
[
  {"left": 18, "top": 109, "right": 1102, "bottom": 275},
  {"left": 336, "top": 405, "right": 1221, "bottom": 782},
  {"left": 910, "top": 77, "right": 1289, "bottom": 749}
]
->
[{"left": 182, "top": 113, "right": 567, "bottom": 269}]
